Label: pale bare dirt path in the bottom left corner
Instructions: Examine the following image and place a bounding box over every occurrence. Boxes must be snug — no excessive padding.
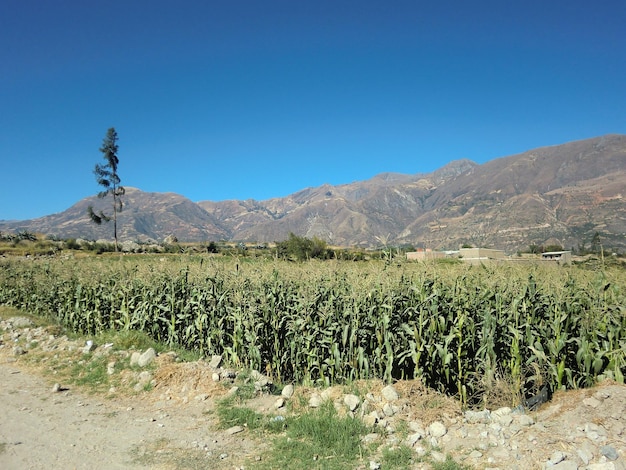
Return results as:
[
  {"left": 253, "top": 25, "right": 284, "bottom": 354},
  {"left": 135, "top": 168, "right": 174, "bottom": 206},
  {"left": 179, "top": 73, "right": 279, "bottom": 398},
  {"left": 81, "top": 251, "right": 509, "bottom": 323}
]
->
[{"left": 0, "top": 358, "right": 255, "bottom": 470}]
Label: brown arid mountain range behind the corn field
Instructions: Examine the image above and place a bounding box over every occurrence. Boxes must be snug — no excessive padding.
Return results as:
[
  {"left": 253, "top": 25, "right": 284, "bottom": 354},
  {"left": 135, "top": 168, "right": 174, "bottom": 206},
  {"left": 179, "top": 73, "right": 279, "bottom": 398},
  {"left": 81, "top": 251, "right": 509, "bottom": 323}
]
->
[{"left": 0, "top": 135, "right": 626, "bottom": 251}]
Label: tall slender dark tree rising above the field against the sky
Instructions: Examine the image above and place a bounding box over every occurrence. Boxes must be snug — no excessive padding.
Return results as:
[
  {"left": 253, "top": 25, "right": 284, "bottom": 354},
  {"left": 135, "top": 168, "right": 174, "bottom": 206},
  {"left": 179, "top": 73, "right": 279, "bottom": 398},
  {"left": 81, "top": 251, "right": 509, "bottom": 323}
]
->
[{"left": 87, "top": 127, "right": 125, "bottom": 251}]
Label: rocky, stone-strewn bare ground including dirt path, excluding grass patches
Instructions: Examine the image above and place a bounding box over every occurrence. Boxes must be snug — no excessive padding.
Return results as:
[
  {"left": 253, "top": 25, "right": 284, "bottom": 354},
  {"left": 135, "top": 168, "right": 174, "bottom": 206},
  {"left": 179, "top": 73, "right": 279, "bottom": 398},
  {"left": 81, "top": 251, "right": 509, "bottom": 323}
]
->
[{"left": 0, "top": 317, "right": 626, "bottom": 470}]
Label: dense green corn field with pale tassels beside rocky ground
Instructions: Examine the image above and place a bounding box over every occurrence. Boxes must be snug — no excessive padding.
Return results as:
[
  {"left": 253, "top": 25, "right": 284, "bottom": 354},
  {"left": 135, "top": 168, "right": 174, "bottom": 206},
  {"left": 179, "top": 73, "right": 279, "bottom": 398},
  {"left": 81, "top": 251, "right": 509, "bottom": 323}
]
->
[{"left": 0, "top": 256, "right": 626, "bottom": 404}]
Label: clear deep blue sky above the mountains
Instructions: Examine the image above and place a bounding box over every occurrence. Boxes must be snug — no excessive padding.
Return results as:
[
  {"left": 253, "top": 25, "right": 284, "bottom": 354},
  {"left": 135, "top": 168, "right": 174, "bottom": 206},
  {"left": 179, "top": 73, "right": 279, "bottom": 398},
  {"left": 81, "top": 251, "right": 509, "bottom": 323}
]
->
[{"left": 0, "top": 0, "right": 626, "bottom": 220}]
